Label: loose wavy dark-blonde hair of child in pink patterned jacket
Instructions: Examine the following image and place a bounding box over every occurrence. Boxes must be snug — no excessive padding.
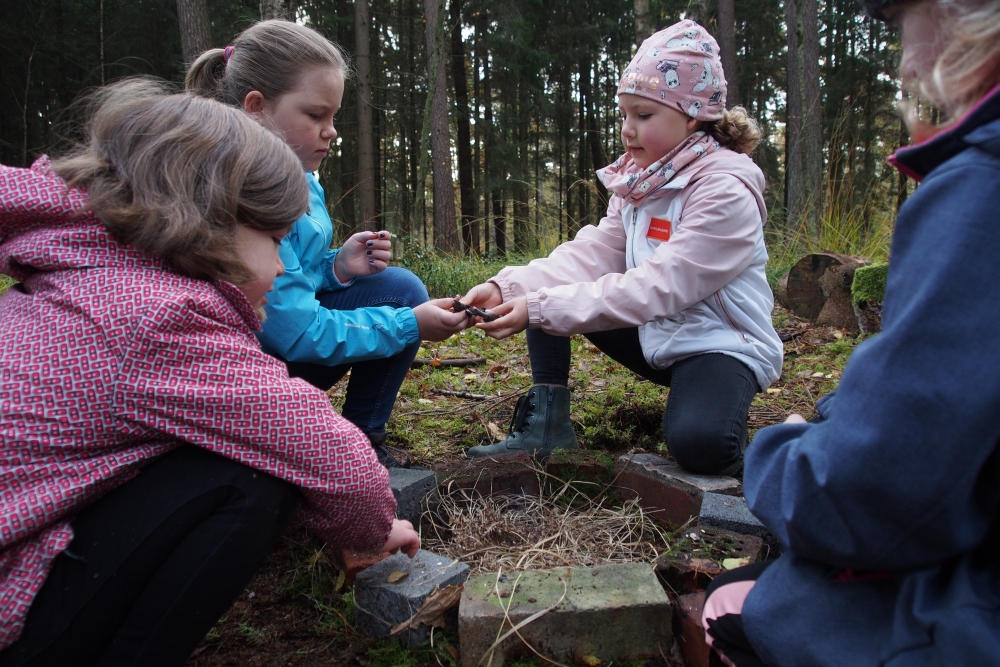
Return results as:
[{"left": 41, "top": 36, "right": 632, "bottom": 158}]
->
[{"left": 52, "top": 79, "right": 309, "bottom": 286}]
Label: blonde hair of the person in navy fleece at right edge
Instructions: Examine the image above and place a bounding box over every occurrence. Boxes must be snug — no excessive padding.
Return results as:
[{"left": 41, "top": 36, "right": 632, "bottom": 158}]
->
[{"left": 902, "top": 0, "right": 1000, "bottom": 140}]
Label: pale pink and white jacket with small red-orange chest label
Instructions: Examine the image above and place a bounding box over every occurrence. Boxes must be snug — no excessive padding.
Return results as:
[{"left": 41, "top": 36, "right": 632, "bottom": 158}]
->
[{"left": 492, "top": 148, "right": 782, "bottom": 389}]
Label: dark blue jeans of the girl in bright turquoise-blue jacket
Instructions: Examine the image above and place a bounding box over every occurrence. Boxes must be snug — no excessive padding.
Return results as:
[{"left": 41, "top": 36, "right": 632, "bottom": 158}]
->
[{"left": 285, "top": 266, "right": 428, "bottom": 433}]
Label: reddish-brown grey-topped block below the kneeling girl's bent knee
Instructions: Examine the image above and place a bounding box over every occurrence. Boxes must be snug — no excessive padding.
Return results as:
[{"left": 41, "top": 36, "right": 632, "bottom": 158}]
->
[{"left": 615, "top": 454, "right": 742, "bottom": 526}]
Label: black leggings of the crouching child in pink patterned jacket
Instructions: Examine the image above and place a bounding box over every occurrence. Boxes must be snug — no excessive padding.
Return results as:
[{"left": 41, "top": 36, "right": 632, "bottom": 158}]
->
[{"left": 0, "top": 445, "right": 298, "bottom": 667}]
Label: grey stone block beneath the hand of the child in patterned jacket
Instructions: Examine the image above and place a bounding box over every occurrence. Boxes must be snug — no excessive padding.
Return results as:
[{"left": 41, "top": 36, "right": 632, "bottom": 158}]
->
[{"left": 354, "top": 549, "right": 469, "bottom": 646}]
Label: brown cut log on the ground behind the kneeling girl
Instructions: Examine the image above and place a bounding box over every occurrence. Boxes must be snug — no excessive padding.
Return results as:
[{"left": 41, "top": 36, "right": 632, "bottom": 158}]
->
[{"left": 776, "top": 252, "right": 871, "bottom": 334}]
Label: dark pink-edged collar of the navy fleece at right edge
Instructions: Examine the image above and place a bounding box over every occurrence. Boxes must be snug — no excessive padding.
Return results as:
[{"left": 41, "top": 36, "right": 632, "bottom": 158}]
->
[{"left": 889, "top": 85, "right": 1000, "bottom": 181}]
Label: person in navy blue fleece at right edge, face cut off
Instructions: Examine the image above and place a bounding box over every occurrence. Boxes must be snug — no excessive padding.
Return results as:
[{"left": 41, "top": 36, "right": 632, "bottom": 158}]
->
[{"left": 703, "top": 0, "right": 1000, "bottom": 667}]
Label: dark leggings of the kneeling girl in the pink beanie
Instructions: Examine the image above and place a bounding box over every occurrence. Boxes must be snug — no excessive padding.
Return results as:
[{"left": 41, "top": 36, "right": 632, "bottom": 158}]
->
[{"left": 527, "top": 327, "right": 760, "bottom": 474}]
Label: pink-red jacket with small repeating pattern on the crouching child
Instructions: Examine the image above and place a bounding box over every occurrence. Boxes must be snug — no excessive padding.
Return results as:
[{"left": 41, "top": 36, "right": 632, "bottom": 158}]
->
[{"left": 0, "top": 158, "right": 396, "bottom": 649}]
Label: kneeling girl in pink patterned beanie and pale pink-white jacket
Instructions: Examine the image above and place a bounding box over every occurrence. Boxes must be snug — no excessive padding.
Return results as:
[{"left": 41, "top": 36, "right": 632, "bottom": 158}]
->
[{"left": 463, "top": 20, "right": 782, "bottom": 474}]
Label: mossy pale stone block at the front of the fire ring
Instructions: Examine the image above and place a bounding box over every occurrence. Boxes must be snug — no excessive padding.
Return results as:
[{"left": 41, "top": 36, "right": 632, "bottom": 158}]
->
[{"left": 458, "top": 563, "right": 673, "bottom": 667}]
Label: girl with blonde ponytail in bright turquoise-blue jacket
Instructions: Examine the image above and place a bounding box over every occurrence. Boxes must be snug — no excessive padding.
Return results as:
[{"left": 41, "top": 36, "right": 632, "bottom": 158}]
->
[{"left": 184, "top": 20, "right": 469, "bottom": 467}]
